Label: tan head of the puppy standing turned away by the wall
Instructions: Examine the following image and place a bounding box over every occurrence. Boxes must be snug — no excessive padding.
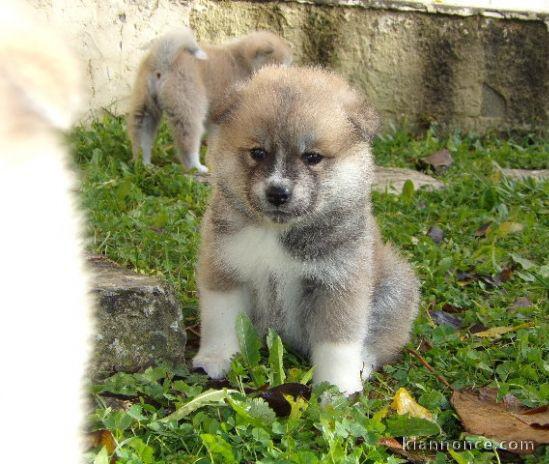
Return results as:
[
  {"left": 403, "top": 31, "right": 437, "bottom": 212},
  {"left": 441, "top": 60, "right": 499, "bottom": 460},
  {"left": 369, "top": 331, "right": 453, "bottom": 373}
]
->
[{"left": 235, "top": 31, "right": 292, "bottom": 73}]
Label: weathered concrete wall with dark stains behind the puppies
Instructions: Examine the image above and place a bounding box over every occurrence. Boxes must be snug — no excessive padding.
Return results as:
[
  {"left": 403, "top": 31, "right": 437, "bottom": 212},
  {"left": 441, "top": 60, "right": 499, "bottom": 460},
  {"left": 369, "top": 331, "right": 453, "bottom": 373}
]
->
[{"left": 27, "top": 0, "right": 549, "bottom": 132}]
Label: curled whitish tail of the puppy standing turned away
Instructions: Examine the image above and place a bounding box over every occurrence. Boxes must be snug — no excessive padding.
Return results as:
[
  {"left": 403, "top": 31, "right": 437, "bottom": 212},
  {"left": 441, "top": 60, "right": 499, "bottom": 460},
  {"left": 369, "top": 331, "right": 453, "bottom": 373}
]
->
[{"left": 151, "top": 27, "right": 208, "bottom": 72}]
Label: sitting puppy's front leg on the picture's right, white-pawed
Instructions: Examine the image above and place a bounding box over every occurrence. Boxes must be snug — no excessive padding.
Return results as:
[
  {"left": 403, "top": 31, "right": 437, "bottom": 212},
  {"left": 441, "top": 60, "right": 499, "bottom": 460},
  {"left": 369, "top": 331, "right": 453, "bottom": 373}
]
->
[{"left": 311, "top": 297, "right": 370, "bottom": 395}]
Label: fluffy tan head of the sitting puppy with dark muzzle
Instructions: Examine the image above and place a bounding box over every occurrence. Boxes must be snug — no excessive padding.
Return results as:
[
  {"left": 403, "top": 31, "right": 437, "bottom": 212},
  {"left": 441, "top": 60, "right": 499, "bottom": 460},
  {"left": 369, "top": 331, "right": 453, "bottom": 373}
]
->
[{"left": 209, "top": 67, "right": 378, "bottom": 223}]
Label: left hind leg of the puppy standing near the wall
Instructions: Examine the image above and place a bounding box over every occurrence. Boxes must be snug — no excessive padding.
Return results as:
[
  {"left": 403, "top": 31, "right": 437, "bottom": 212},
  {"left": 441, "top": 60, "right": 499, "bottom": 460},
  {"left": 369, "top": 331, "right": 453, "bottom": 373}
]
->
[{"left": 128, "top": 103, "right": 162, "bottom": 165}]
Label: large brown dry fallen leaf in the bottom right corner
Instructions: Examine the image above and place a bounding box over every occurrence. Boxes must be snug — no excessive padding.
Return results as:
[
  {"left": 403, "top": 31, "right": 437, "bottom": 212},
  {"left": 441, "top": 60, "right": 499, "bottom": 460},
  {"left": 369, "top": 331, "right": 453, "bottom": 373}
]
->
[{"left": 450, "top": 389, "right": 549, "bottom": 454}]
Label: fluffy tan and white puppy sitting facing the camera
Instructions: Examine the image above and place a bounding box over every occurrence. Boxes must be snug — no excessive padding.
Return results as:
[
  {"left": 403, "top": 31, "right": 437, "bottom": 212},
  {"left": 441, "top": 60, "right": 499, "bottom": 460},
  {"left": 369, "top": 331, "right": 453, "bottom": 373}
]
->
[{"left": 193, "top": 67, "right": 419, "bottom": 394}]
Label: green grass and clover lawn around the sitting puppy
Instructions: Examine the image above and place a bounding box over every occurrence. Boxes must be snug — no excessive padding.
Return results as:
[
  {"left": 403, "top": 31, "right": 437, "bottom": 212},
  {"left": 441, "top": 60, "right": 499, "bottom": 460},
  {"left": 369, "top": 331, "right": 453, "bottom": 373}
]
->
[{"left": 71, "top": 117, "right": 549, "bottom": 464}]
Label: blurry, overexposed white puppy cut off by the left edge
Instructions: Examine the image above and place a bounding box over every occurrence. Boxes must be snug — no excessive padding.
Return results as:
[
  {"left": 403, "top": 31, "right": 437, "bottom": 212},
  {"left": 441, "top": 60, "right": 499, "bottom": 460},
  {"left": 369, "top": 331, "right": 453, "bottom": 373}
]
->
[{"left": 0, "top": 1, "right": 91, "bottom": 464}]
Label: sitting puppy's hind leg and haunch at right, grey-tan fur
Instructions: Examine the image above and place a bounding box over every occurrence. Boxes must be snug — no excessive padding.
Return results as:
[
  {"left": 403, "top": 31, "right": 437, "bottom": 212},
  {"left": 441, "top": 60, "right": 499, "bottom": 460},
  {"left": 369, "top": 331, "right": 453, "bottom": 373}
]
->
[{"left": 362, "top": 245, "right": 419, "bottom": 371}]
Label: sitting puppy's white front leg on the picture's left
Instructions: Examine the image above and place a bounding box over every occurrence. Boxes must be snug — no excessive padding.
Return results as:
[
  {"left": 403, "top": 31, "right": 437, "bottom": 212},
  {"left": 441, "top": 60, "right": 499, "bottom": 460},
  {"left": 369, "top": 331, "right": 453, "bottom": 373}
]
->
[{"left": 193, "top": 287, "right": 249, "bottom": 379}]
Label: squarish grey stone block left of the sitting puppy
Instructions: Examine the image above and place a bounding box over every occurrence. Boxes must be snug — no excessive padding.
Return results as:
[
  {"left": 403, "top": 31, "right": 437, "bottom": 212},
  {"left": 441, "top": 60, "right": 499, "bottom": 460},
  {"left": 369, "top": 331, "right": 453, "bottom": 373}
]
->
[{"left": 88, "top": 256, "right": 187, "bottom": 380}]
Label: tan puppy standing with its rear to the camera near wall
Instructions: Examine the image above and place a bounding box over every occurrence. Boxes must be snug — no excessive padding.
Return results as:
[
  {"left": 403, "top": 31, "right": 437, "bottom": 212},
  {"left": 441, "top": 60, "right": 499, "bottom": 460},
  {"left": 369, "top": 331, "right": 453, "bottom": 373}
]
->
[{"left": 128, "top": 29, "right": 292, "bottom": 172}]
